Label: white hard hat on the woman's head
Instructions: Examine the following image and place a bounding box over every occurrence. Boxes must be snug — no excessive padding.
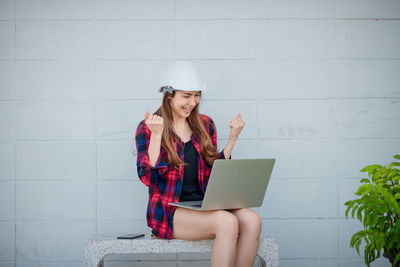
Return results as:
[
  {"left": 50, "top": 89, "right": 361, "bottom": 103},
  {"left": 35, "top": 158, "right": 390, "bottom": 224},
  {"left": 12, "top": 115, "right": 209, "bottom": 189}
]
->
[{"left": 159, "top": 61, "right": 206, "bottom": 94}]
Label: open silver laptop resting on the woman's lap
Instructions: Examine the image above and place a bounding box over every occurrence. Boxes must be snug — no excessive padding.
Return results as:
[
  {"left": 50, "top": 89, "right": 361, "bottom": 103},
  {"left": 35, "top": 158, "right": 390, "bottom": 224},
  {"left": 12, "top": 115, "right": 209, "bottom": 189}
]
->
[{"left": 168, "top": 159, "right": 275, "bottom": 210}]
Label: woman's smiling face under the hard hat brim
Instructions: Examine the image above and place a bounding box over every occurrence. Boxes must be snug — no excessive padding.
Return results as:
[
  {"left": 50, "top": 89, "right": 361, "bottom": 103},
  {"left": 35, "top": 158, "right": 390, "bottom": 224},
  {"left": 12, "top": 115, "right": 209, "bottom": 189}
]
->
[{"left": 171, "top": 91, "right": 201, "bottom": 119}]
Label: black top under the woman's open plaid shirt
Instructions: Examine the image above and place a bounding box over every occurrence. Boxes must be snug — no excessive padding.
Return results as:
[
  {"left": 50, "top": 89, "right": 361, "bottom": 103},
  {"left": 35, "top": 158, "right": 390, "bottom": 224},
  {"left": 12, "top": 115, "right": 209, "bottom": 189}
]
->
[{"left": 179, "top": 140, "right": 204, "bottom": 201}]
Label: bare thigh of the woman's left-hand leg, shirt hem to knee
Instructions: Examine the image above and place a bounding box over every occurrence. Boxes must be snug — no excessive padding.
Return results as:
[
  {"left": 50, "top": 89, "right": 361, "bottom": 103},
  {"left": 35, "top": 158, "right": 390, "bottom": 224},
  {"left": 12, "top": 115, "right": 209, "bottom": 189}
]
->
[{"left": 173, "top": 208, "right": 238, "bottom": 240}]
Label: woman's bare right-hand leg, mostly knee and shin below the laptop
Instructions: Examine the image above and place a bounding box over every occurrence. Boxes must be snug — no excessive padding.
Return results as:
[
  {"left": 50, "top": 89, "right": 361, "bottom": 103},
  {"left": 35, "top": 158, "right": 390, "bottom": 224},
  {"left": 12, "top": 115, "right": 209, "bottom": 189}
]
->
[{"left": 231, "top": 209, "right": 261, "bottom": 267}]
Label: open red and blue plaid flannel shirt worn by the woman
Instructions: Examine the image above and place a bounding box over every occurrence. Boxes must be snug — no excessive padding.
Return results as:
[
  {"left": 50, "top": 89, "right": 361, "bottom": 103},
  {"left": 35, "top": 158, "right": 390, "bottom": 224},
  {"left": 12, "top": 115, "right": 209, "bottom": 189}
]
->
[{"left": 135, "top": 114, "right": 225, "bottom": 239}]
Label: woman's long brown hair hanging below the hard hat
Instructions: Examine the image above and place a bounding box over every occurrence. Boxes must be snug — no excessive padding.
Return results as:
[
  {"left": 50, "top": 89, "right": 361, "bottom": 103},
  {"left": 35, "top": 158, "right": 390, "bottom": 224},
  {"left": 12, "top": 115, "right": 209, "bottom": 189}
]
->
[{"left": 154, "top": 91, "right": 218, "bottom": 167}]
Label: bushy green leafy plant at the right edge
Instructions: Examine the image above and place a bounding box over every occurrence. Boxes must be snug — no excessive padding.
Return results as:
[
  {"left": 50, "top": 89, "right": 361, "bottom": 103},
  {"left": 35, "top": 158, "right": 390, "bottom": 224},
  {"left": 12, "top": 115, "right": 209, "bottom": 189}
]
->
[{"left": 345, "top": 155, "right": 400, "bottom": 267}]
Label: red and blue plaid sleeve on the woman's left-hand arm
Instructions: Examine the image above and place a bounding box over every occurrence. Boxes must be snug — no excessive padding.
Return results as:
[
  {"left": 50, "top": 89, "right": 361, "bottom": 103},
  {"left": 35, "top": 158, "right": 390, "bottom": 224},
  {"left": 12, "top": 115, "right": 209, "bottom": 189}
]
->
[{"left": 135, "top": 120, "right": 168, "bottom": 186}]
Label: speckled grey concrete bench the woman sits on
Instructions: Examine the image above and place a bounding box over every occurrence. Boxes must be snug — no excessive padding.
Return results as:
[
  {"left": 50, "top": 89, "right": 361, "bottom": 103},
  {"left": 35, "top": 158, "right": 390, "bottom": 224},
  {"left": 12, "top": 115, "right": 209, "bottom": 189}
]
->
[{"left": 84, "top": 235, "right": 279, "bottom": 267}]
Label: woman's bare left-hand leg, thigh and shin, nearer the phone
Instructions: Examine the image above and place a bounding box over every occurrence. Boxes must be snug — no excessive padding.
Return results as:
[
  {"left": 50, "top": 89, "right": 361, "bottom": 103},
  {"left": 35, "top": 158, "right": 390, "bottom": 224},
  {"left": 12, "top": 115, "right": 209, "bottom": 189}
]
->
[{"left": 173, "top": 208, "right": 239, "bottom": 267}]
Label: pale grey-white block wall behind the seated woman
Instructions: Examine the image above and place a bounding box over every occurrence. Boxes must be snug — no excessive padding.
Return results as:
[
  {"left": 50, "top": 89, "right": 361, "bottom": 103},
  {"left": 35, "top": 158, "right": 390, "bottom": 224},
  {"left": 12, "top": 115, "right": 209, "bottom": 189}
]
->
[{"left": 0, "top": 0, "right": 400, "bottom": 267}]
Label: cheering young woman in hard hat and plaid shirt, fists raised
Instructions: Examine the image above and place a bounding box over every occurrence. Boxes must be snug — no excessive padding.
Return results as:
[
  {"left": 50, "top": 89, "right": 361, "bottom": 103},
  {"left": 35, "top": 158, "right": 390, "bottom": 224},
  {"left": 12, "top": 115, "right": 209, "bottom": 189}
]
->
[{"left": 136, "top": 61, "right": 261, "bottom": 267}]
